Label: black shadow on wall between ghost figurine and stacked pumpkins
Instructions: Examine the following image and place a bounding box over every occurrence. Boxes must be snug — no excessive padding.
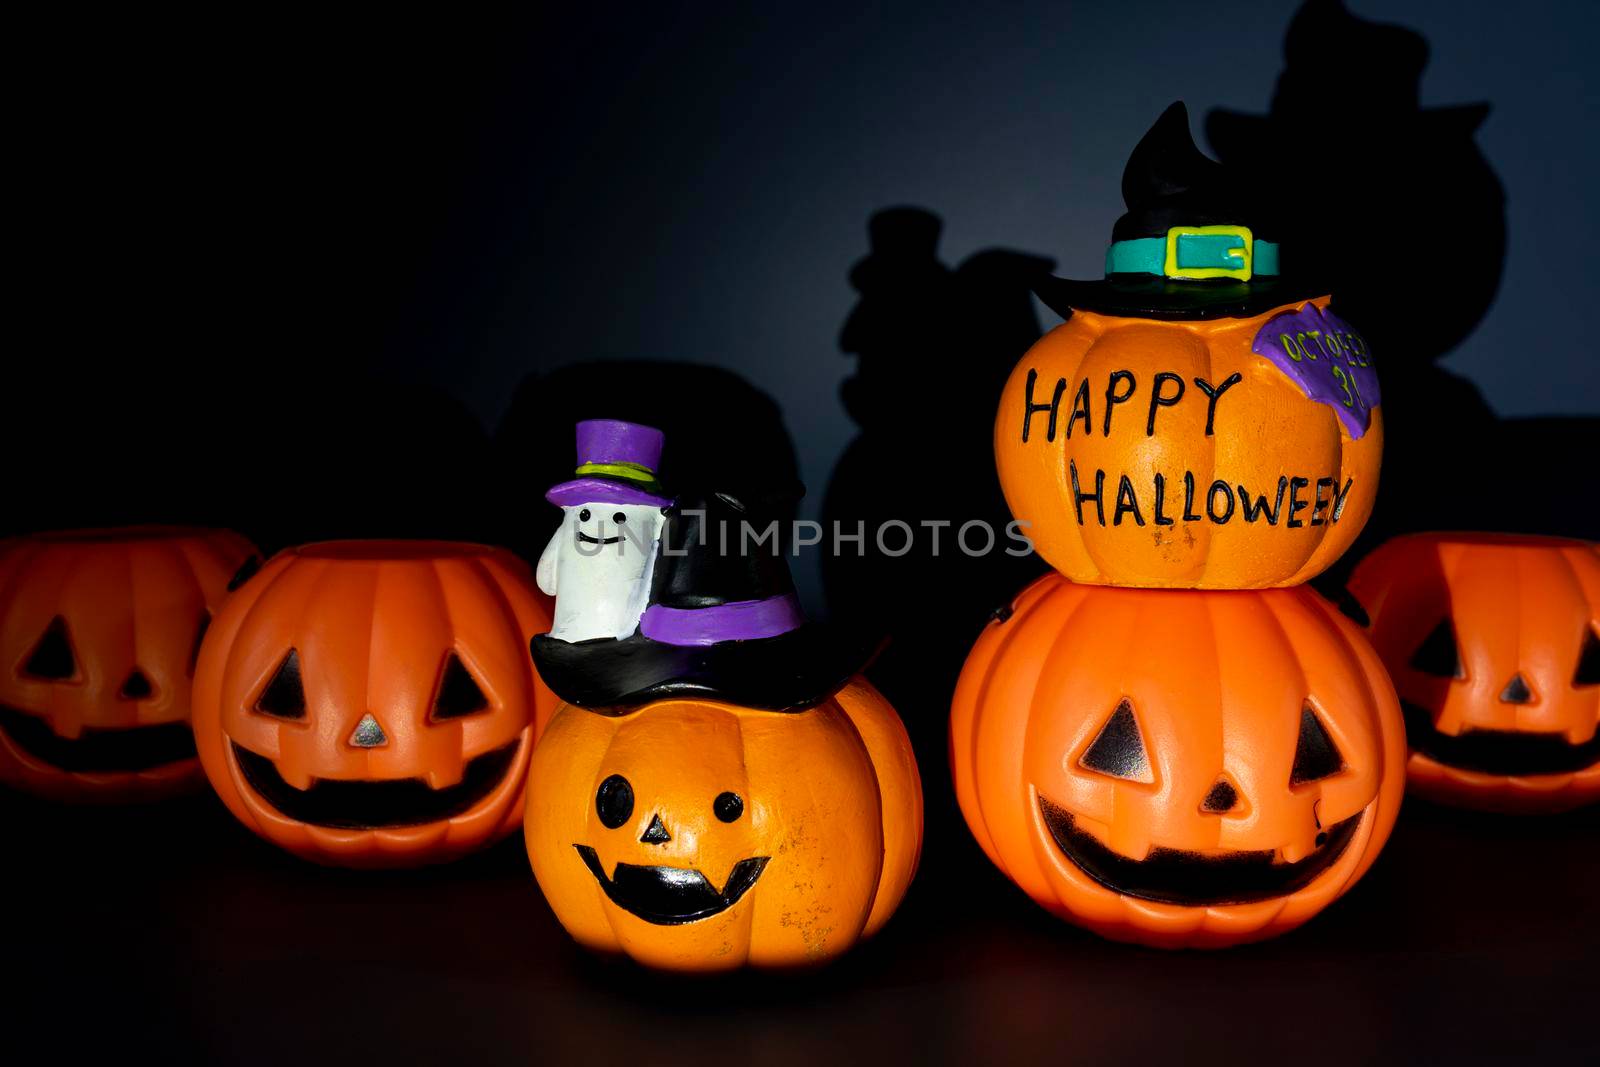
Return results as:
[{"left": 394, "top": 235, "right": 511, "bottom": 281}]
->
[{"left": 822, "top": 208, "right": 1054, "bottom": 865}]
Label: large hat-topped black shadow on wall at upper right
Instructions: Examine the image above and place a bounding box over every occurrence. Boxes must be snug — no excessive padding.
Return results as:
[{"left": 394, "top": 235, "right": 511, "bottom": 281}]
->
[{"left": 1206, "top": 0, "right": 1600, "bottom": 572}]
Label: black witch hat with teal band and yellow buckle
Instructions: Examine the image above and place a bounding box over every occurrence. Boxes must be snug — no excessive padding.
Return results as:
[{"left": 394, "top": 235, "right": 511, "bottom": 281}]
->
[{"left": 1034, "top": 102, "right": 1326, "bottom": 318}]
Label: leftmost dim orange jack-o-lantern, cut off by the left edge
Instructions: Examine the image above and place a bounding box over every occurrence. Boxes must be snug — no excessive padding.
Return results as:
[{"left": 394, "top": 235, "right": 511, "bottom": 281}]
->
[{"left": 0, "top": 528, "right": 254, "bottom": 801}]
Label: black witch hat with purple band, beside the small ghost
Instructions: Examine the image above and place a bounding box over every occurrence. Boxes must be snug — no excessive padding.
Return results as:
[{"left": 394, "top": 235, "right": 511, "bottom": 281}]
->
[{"left": 530, "top": 493, "right": 861, "bottom": 712}]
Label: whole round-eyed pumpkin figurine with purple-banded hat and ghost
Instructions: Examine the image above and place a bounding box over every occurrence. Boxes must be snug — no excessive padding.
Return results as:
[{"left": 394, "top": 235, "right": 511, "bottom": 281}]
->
[{"left": 523, "top": 422, "right": 922, "bottom": 971}]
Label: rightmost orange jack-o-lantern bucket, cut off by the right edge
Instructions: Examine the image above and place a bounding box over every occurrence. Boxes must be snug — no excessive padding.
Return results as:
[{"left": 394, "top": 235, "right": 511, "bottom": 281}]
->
[{"left": 1350, "top": 533, "right": 1600, "bottom": 813}]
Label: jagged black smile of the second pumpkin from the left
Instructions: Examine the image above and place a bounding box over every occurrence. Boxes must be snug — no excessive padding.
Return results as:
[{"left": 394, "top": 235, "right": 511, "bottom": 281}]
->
[{"left": 232, "top": 741, "right": 522, "bottom": 830}]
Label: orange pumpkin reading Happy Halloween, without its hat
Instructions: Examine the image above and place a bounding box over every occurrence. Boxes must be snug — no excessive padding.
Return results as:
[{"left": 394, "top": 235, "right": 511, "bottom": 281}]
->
[{"left": 995, "top": 298, "right": 1384, "bottom": 589}]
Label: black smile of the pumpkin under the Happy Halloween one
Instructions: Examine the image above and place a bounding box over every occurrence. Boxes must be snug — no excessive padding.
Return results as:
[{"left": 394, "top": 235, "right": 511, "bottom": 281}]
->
[{"left": 1038, "top": 797, "right": 1362, "bottom": 907}]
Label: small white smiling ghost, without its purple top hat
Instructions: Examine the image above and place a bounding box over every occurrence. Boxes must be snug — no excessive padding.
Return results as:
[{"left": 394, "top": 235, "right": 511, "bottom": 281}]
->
[{"left": 538, "top": 504, "right": 662, "bottom": 641}]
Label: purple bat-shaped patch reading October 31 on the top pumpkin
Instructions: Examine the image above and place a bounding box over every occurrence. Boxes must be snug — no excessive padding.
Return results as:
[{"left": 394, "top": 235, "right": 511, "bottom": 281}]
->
[{"left": 1250, "top": 304, "right": 1382, "bottom": 437}]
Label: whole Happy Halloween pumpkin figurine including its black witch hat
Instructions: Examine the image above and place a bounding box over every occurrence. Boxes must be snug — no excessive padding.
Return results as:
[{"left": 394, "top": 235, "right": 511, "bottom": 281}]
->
[{"left": 995, "top": 104, "right": 1382, "bottom": 589}]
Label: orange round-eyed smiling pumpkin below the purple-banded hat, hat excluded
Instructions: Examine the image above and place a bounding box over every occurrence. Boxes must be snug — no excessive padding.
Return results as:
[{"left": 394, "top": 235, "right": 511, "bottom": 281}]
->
[{"left": 523, "top": 678, "right": 922, "bottom": 971}]
